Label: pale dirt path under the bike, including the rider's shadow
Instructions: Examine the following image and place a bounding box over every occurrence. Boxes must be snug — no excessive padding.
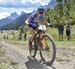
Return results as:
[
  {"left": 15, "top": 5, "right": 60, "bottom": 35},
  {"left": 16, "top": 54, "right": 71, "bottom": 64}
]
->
[{"left": 2, "top": 42, "right": 75, "bottom": 69}]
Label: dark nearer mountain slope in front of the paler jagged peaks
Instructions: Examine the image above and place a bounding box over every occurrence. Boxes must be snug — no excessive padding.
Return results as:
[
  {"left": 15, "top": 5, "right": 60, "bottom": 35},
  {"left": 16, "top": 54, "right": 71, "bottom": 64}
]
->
[{"left": 0, "top": 12, "right": 30, "bottom": 30}]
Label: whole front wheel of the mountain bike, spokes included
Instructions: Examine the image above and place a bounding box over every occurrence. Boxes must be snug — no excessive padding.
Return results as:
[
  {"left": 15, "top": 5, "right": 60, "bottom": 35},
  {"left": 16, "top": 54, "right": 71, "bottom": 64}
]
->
[{"left": 40, "top": 34, "right": 56, "bottom": 65}]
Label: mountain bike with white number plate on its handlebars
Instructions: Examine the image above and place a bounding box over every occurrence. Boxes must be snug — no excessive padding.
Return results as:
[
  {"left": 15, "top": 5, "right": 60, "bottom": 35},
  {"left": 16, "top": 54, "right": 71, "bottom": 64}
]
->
[{"left": 29, "top": 25, "right": 56, "bottom": 65}]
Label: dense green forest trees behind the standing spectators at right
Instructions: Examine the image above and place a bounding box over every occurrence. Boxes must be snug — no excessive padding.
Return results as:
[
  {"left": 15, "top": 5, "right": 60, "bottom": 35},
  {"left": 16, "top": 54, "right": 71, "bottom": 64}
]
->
[{"left": 45, "top": 0, "right": 75, "bottom": 25}]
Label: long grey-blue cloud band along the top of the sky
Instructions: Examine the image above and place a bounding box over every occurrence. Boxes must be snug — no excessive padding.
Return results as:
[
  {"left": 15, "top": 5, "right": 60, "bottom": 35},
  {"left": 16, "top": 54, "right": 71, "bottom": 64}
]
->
[{"left": 0, "top": 0, "right": 51, "bottom": 8}]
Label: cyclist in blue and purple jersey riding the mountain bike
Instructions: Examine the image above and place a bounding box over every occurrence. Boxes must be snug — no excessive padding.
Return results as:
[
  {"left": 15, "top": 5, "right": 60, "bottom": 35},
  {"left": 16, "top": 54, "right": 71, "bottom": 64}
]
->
[{"left": 25, "top": 8, "right": 47, "bottom": 49}]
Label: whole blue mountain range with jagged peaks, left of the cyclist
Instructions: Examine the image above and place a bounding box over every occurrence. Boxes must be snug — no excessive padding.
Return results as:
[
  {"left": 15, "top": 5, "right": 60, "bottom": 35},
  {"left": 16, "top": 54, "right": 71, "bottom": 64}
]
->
[{"left": 0, "top": 12, "right": 30, "bottom": 30}]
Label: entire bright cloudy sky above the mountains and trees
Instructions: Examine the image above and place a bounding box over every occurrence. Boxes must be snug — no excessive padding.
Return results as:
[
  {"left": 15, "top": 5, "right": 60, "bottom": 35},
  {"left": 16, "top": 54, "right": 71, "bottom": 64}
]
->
[{"left": 0, "top": 0, "right": 51, "bottom": 19}]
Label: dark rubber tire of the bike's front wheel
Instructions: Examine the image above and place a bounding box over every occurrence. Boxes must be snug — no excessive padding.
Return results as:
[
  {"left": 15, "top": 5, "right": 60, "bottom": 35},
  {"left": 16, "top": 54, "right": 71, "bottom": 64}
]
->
[{"left": 40, "top": 34, "right": 56, "bottom": 65}]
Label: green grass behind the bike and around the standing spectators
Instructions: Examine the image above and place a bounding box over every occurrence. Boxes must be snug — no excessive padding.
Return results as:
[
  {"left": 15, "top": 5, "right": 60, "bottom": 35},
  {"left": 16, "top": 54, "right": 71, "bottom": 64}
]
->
[{"left": 0, "top": 25, "right": 75, "bottom": 47}]
